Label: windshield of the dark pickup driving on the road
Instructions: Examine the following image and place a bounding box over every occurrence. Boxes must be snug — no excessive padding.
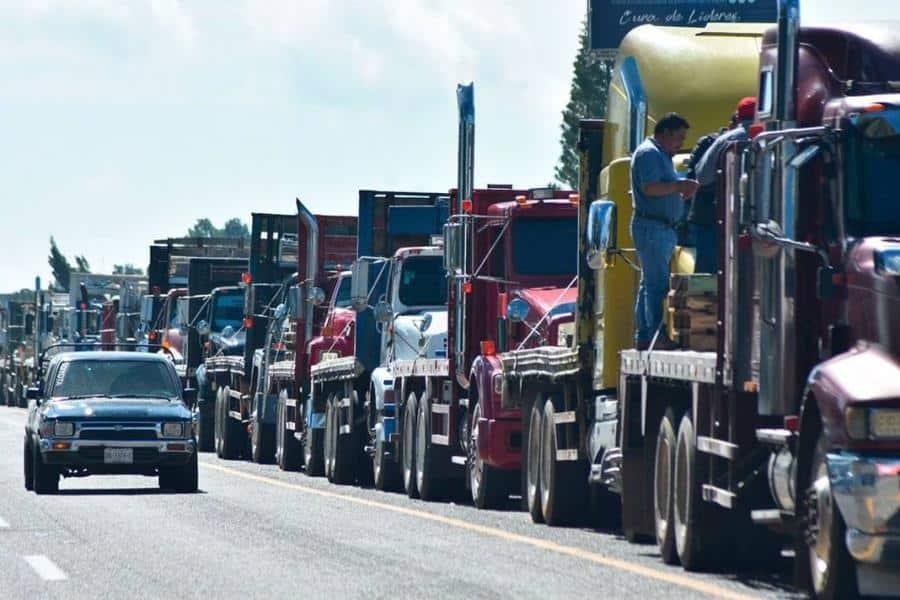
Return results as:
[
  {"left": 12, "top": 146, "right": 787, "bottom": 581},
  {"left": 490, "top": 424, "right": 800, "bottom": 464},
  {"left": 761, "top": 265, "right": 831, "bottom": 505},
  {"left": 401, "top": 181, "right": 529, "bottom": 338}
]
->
[{"left": 50, "top": 360, "right": 178, "bottom": 398}]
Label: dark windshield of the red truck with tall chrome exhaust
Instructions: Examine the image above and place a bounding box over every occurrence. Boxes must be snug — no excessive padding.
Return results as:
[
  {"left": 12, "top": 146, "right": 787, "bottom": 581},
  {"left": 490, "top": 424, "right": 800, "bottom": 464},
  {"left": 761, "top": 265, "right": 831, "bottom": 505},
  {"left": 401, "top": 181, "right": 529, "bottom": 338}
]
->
[{"left": 512, "top": 217, "right": 578, "bottom": 277}]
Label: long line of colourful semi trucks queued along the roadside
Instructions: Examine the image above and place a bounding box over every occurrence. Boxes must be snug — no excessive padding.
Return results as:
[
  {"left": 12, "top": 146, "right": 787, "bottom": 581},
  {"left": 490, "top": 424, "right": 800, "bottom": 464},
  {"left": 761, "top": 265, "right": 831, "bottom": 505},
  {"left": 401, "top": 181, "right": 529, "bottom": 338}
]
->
[{"left": 7, "top": 0, "right": 900, "bottom": 597}]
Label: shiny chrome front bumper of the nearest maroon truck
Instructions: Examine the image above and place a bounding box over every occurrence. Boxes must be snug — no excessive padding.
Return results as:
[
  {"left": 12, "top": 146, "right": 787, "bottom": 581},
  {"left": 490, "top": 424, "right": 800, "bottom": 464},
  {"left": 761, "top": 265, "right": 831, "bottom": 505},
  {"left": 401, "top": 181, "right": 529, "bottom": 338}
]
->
[{"left": 827, "top": 452, "right": 900, "bottom": 596}]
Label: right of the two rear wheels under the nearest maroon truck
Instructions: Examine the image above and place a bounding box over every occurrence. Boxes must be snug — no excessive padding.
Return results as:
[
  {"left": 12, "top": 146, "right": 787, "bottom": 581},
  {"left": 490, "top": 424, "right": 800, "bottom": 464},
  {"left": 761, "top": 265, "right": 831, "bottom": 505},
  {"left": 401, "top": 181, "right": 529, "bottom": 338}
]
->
[{"left": 673, "top": 415, "right": 731, "bottom": 571}]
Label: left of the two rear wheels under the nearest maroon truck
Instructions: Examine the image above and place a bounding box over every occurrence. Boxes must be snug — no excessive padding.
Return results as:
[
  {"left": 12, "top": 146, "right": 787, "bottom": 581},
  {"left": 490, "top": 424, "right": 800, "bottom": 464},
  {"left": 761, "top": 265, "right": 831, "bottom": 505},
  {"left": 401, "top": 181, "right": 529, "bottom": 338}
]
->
[{"left": 653, "top": 408, "right": 678, "bottom": 565}]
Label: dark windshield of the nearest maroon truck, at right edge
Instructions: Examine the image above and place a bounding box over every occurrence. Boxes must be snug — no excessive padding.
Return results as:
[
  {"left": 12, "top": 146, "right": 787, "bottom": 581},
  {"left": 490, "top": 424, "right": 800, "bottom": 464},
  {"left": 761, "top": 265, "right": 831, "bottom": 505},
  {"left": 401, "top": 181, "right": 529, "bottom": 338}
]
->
[{"left": 847, "top": 112, "right": 900, "bottom": 237}]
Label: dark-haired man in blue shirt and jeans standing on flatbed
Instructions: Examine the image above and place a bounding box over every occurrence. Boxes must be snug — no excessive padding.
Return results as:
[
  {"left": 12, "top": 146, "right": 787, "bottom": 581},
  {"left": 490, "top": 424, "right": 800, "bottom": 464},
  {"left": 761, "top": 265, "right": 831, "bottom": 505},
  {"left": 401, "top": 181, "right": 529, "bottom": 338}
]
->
[{"left": 631, "top": 113, "right": 698, "bottom": 350}]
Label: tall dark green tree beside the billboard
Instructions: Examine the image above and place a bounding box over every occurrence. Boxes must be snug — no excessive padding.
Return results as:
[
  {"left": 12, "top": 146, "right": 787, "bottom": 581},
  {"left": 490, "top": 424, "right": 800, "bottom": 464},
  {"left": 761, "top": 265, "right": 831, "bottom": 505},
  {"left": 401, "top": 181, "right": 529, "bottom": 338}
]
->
[{"left": 554, "top": 20, "right": 613, "bottom": 190}]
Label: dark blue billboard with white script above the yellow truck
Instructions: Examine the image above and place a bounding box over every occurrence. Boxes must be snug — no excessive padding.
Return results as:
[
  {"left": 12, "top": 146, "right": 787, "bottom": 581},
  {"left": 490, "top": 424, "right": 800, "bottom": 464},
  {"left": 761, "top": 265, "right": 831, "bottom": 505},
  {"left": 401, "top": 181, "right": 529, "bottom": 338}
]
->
[{"left": 588, "top": 0, "right": 778, "bottom": 56}]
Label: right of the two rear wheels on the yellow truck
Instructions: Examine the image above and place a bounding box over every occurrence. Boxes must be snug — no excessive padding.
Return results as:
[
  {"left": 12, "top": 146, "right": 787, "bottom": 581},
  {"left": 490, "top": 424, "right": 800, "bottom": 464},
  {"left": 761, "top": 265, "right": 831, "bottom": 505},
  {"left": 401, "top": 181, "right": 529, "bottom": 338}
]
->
[{"left": 540, "top": 398, "right": 587, "bottom": 527}]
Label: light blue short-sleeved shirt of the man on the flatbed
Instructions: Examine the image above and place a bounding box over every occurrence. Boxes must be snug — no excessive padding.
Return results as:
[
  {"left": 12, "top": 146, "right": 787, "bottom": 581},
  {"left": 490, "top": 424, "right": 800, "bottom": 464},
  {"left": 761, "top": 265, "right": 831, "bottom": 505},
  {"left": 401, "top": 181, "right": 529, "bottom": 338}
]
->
[{"left": 631, "top": 137, "right": 684, "bottom": 223}]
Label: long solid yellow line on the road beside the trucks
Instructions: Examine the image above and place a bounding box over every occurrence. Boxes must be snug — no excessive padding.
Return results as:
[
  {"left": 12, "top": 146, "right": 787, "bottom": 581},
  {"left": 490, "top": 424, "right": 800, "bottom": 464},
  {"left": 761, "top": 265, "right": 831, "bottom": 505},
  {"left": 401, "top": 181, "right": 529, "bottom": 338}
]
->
[{"left": 200, "top": 462, "right": 755, "bottom": 600}]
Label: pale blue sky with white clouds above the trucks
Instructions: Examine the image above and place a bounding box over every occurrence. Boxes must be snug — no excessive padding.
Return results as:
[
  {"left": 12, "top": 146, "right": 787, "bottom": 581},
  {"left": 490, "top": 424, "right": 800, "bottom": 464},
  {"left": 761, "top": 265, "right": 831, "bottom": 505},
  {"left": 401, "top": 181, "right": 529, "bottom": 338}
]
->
[{"left": 0, "top": 0, "right": 900, "bottom": 291}]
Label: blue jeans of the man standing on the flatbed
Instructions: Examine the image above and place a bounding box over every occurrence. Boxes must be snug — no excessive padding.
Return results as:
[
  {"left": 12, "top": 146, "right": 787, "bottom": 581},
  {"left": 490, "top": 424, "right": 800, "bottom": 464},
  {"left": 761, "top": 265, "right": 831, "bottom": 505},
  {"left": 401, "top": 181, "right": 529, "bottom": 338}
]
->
[{"left": 631, "top": 217, "right": 678, "bottom": 342}]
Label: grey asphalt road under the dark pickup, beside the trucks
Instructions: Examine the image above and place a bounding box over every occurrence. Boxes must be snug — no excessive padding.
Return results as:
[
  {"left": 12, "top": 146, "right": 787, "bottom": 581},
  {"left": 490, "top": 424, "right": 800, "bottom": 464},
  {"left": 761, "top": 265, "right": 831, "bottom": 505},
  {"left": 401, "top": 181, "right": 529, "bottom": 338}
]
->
[{"left": 0, "top": 407, "right": 795, "bottom": 600}]
